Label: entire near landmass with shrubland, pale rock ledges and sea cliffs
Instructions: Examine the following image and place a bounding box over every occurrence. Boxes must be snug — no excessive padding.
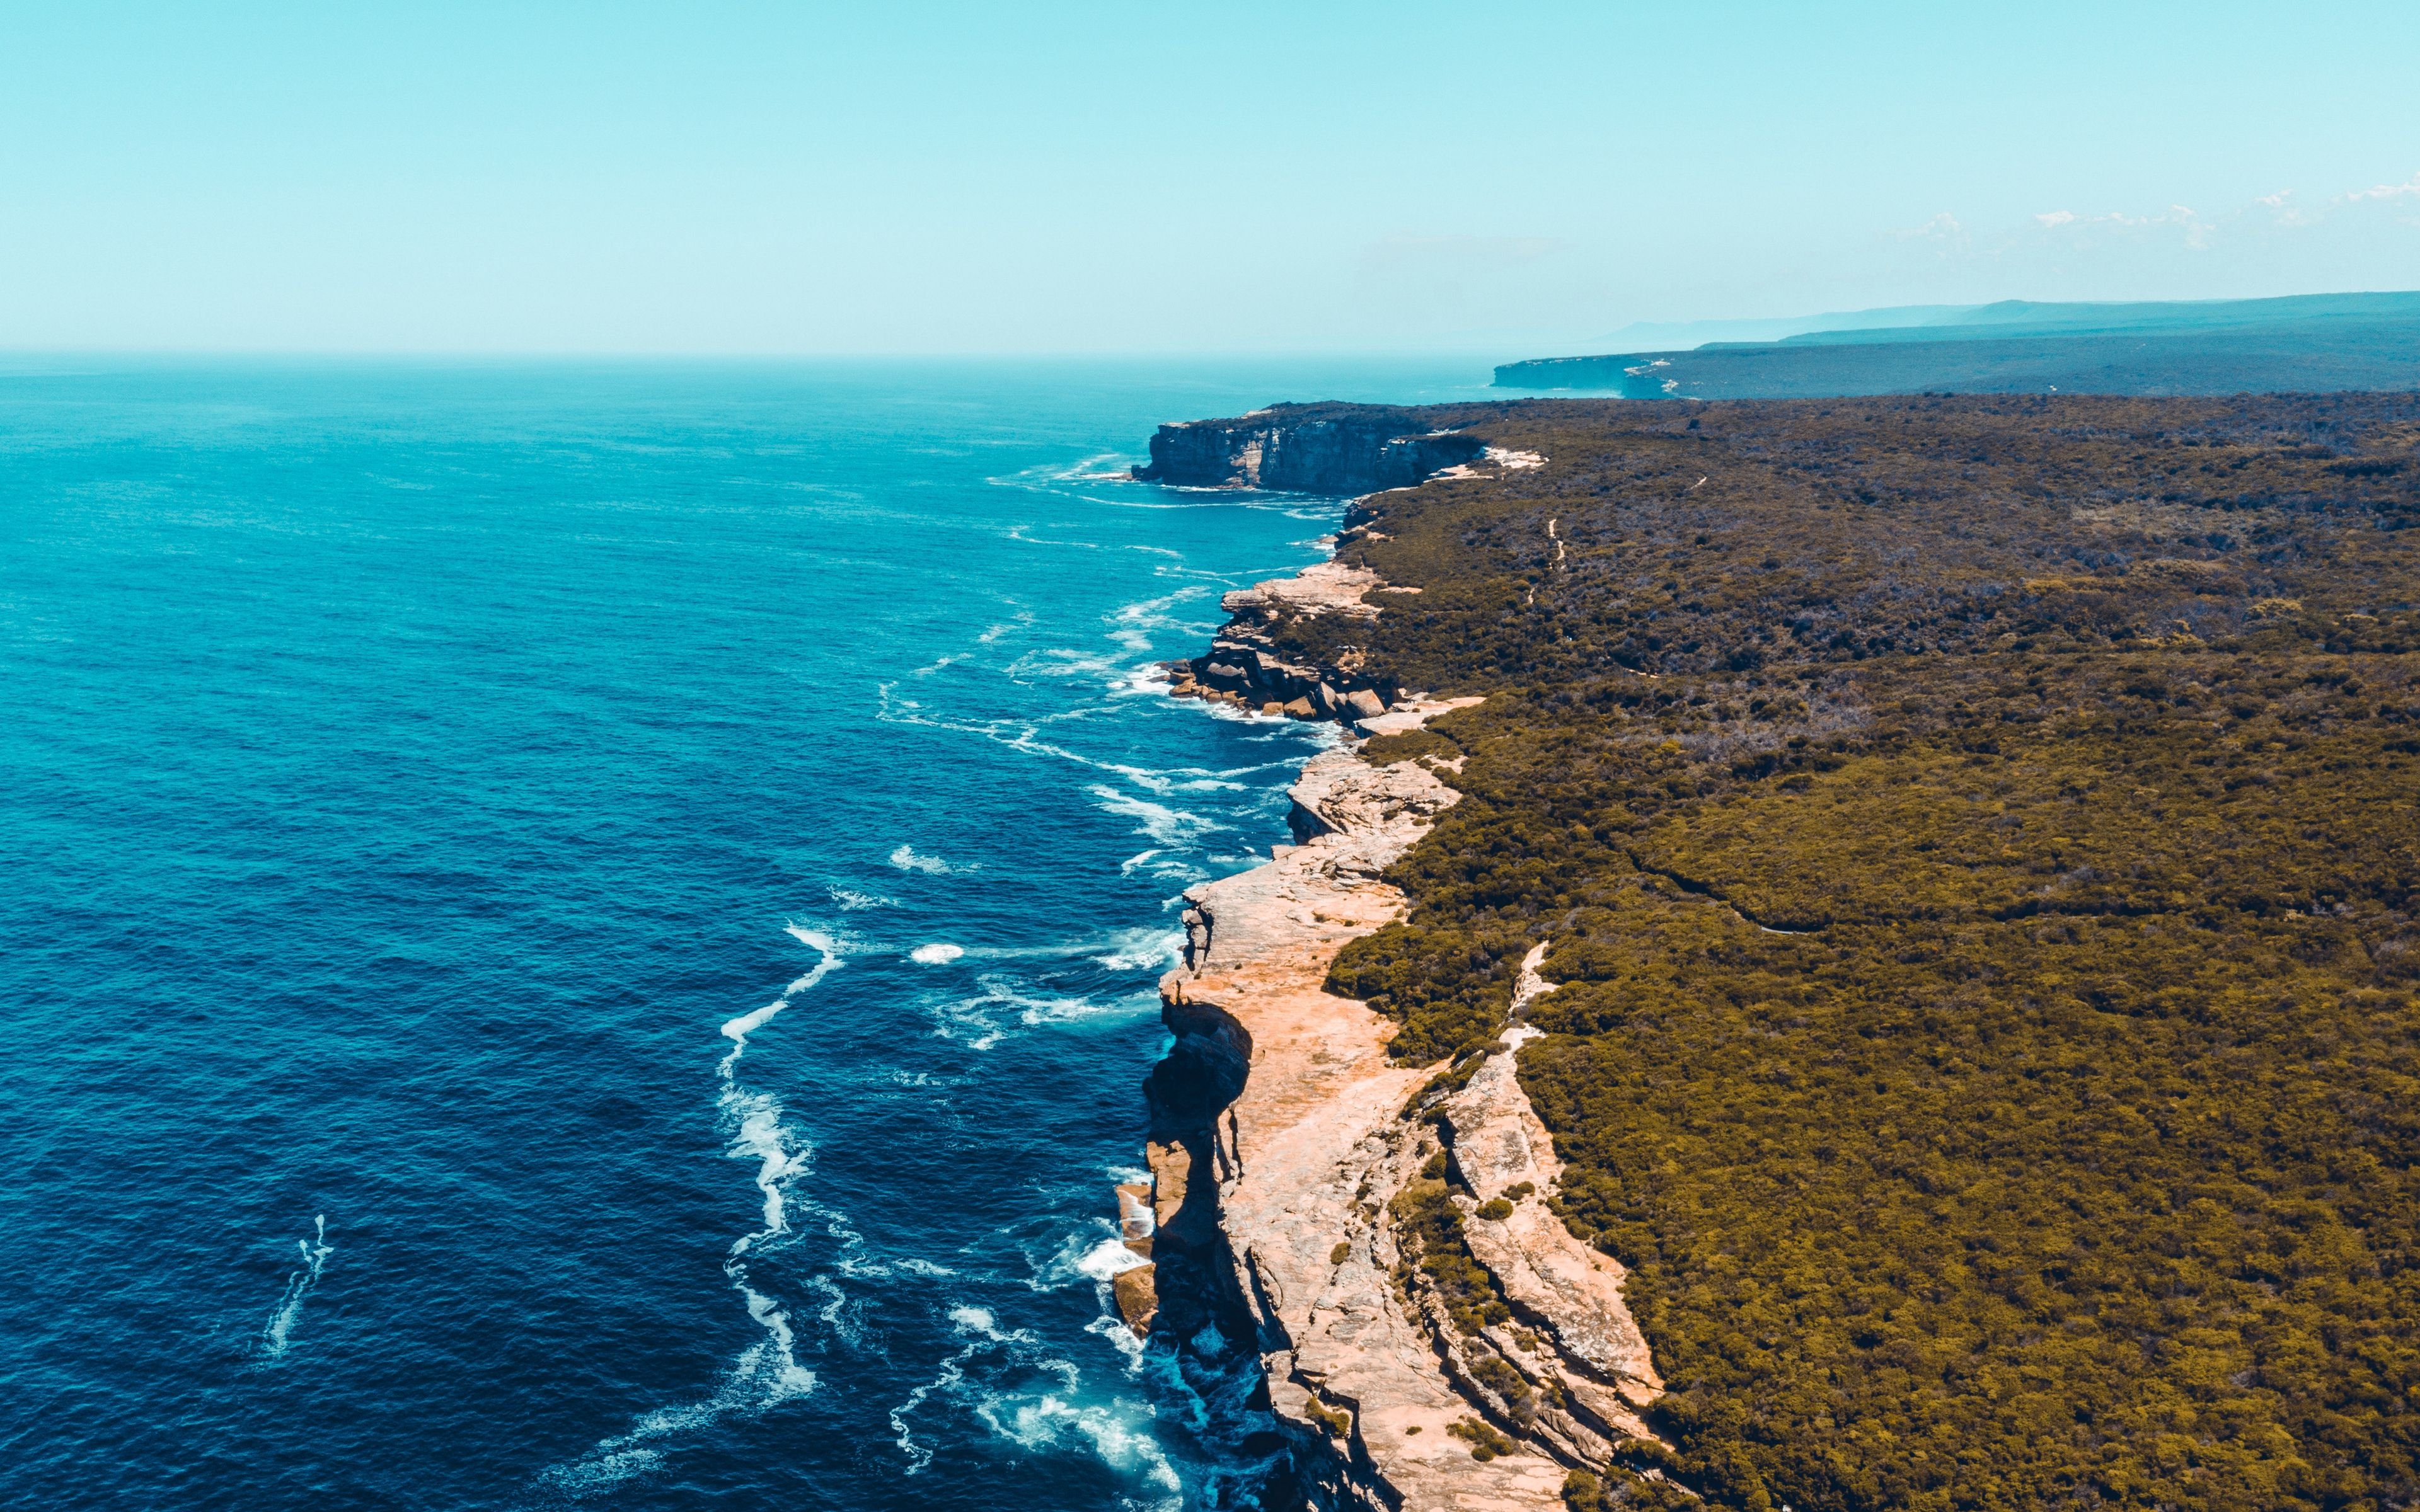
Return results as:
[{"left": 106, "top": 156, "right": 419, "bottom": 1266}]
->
[{"left": 1118, "top": 394, "right": 2420, "bottom": 1512}]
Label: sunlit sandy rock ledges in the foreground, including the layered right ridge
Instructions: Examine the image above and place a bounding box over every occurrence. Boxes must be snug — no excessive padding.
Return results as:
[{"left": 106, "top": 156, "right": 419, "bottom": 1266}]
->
[{"left": 1121, "top": 699, "right": 1660, "bottom": 1512}]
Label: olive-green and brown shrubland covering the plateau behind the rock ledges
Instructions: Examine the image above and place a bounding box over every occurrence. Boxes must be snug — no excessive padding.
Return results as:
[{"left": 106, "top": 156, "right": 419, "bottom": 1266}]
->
[{"left": 1285, "top": 394, "right": 2420, "bottom": 1512}]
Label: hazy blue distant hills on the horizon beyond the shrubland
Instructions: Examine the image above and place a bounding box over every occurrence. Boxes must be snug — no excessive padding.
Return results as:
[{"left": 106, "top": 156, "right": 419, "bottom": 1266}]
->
[{"left": 1495, "top": 293, "right": 2420, "bottom": 399}]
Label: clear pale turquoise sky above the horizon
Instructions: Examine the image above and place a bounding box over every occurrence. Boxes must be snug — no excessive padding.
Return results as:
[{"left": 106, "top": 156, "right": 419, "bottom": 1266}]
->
[{"left": 0, "top": 0, "right": 2420, "bottom": 355}]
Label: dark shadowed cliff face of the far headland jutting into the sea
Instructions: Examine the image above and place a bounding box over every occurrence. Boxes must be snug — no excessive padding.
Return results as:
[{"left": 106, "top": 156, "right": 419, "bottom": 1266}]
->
[{"left": 1132, "top": 404, "right": 1486, "bottom": 493}]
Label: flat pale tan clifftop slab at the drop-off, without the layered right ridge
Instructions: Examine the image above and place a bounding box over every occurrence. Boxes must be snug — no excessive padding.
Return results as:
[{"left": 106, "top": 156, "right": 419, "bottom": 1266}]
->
[{"left": 1152, "top": 701, "right": 1564, "bottom": 1512}]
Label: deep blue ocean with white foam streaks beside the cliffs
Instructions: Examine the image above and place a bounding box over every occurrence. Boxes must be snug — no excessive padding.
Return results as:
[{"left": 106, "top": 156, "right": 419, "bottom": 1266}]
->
[{"left": 0, "top": 360, "right": 1486, "bottom": 1512}]
